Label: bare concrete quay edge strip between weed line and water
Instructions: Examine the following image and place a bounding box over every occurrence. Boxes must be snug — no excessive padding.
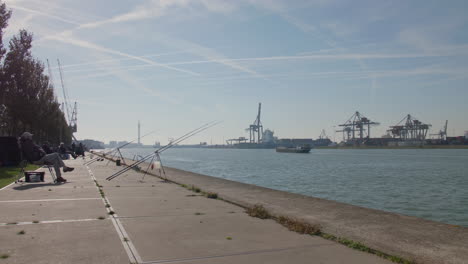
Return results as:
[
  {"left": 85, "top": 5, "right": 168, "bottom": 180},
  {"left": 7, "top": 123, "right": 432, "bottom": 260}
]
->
[{"left": 99, "top": 153, "right": 468, "bottom": 264}]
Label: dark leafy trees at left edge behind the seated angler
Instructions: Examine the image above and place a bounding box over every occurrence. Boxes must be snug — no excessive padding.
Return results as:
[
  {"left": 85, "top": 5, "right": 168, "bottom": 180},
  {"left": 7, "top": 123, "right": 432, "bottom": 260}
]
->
[{"left": 0, "top": 0, "right": 72, "bottom": 143}]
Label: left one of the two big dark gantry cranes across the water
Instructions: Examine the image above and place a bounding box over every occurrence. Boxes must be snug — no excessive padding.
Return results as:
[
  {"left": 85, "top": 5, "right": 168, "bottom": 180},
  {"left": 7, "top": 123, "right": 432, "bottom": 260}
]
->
[{"left": 336, "top": 111, "right": 380, "bottom": 143}]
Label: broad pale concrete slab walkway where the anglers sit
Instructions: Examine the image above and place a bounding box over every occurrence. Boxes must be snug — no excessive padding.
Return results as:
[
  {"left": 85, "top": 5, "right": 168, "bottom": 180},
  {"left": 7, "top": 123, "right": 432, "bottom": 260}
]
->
[{"left": 0, "top": 160, "right": 390, "bottom": 264}]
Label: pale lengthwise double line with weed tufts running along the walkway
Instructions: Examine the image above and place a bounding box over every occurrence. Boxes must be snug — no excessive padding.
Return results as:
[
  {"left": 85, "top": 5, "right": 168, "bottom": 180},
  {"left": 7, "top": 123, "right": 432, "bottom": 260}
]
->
[{"left": 85, "top": 165, "right": 143, "bottom": 263}]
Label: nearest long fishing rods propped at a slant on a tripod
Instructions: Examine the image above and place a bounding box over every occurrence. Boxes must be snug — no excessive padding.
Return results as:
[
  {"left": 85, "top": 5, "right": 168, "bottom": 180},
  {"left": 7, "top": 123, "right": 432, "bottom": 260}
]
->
[{"left": 106, "top": 121, "right": 221, "bottom": 181}]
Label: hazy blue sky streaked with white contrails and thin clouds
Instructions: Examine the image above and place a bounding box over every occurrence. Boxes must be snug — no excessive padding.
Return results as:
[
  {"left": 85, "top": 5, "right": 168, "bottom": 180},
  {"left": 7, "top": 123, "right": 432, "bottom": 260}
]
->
[{"left": 3, "top": 0, "right": 468, "bottom": 144}]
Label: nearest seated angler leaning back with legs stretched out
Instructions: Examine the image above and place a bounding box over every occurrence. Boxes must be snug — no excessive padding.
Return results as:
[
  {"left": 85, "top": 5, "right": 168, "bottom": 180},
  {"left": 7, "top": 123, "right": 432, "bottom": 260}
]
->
[{"left": 19, "top": 132, "right": 74, "bottom": 182}]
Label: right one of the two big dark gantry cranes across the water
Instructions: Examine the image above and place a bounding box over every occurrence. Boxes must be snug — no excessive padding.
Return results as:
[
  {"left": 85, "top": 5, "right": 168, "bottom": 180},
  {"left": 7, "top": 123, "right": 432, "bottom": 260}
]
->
[{"left": 387, "top": 114, "right": 432, "bottom": 140}]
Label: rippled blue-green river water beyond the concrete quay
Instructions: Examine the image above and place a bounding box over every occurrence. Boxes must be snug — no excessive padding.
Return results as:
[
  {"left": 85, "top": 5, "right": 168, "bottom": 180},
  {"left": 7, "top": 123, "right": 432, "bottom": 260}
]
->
[{"left": 122, "top": 148, "right": 468, "bottom": 227}]
